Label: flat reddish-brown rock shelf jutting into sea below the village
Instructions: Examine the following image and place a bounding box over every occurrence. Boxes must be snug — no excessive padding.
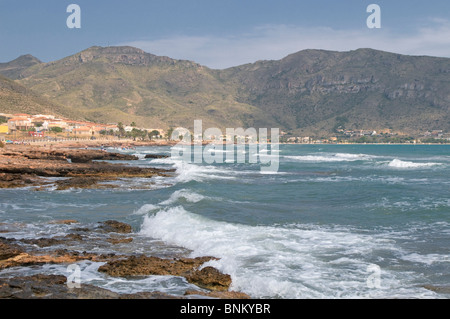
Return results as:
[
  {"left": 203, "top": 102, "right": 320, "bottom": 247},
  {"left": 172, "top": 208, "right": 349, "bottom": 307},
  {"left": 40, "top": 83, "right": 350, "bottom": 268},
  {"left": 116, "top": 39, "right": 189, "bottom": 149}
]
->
[{"left": 0, "top": 145, "right": 173, "bottom": 190}]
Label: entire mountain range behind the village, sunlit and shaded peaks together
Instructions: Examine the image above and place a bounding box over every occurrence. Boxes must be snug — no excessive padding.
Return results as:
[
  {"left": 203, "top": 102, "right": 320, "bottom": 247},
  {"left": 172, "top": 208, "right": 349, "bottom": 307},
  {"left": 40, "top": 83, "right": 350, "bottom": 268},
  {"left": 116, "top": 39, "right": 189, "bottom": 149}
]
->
[{"left": 0, "top": 47, "right": 450, "bottom": 135}]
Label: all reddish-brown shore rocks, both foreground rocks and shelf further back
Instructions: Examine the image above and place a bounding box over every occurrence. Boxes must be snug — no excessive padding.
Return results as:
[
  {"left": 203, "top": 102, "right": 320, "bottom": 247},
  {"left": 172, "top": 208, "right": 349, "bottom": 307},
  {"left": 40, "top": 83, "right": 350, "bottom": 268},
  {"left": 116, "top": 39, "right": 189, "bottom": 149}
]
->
[{"left": 0, "top": 145, "right": 249, "bottom": 299}]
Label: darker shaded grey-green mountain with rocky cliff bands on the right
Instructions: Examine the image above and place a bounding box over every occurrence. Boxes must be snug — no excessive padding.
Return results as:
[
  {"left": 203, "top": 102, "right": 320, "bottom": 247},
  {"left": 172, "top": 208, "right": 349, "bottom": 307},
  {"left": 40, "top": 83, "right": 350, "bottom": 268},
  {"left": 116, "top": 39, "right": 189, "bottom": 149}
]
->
[{"left": 222, "top": 49, "right": 450, "bottom": 133}]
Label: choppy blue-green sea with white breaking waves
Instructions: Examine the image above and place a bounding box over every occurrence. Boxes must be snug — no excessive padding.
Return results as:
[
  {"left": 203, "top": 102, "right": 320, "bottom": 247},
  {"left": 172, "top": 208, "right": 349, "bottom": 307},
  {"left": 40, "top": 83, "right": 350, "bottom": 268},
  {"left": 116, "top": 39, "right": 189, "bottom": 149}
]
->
[{"left": 0, "top": 144, "right": 450, "bottom": 299}]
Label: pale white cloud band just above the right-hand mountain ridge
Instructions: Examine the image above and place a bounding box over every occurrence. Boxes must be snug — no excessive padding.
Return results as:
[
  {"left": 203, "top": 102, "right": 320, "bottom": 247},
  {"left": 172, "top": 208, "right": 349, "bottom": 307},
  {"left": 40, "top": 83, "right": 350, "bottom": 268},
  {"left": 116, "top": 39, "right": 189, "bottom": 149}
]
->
[{"left": 120, "top": 19, "right": 450, "bottom": 69}]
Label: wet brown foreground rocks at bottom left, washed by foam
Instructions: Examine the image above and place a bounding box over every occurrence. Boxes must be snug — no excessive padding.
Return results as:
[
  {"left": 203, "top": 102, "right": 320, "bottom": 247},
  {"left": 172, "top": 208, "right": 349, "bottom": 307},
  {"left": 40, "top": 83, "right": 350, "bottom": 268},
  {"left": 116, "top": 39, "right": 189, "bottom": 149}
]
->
[{"left": 0, "top": 220, "right": 250, "bottom": 299}]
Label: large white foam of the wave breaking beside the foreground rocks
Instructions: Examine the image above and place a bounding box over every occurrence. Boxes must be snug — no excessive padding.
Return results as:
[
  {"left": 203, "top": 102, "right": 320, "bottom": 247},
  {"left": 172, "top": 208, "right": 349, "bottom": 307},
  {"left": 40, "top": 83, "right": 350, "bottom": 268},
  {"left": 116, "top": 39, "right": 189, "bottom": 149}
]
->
[{"left": 140, "top": 206, "right": 435, "bottom": 298}]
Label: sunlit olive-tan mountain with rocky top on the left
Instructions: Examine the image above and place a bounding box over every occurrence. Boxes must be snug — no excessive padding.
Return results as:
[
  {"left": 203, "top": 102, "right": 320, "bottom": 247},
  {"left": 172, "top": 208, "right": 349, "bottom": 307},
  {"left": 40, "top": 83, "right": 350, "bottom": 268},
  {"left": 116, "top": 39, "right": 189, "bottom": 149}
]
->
[{"left": 6, "top": 47, "right": 264, "bottom": 127}]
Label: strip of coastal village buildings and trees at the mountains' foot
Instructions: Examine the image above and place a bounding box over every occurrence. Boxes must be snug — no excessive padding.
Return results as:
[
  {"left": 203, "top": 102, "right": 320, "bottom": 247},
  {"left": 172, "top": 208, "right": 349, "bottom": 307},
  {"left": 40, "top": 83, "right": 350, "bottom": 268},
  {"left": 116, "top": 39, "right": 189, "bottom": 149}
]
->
[{"left": 0, "top": 113, "right": 450, "bottom": 144}]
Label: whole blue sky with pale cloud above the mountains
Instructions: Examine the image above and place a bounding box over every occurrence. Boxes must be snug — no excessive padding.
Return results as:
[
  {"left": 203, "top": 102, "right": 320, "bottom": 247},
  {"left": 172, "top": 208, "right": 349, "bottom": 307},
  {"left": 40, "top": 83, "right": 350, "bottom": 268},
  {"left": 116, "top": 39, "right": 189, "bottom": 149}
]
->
[{"left": 0, "top": 0, "right": 450, "bottom": 69}]
